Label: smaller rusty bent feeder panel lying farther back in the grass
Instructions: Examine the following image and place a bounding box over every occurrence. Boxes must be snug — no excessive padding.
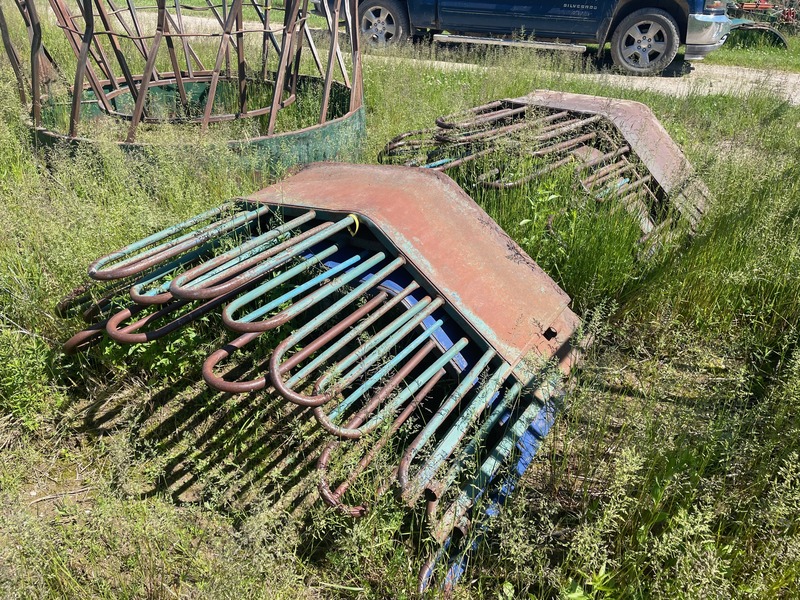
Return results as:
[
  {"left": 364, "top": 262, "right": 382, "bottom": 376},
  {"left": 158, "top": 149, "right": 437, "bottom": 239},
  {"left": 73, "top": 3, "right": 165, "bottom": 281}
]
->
[{"left": 379, "top": 91, "right": 708, "bottom": 241}]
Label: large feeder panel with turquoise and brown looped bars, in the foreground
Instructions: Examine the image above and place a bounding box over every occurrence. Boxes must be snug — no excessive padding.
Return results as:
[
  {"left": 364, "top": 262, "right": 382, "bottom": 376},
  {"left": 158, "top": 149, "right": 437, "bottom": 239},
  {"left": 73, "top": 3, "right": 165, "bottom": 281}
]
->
[{"left": 59, "top": 163, "right": 580, "bottom": 585}]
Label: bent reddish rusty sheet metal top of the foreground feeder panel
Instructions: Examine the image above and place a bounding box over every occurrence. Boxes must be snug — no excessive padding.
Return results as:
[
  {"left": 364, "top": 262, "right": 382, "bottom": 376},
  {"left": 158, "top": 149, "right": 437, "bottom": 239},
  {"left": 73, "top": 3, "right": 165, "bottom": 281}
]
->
[{"left": 249, "top": 163, "right": 580, "bottom": 371}]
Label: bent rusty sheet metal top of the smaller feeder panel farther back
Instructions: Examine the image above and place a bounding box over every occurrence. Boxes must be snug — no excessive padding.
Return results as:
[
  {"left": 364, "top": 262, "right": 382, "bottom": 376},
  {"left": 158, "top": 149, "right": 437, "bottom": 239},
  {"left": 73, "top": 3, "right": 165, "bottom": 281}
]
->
[{"left": 515, "top": 90, "right": 709, "bottom": 227}]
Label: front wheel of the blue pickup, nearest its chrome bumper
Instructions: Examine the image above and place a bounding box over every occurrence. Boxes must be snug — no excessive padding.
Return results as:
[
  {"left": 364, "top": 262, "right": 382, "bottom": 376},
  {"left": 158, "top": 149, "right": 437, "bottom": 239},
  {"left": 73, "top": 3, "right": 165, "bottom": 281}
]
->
[{"left": 611, "top": 8, "right": 680, "bottom": 75}]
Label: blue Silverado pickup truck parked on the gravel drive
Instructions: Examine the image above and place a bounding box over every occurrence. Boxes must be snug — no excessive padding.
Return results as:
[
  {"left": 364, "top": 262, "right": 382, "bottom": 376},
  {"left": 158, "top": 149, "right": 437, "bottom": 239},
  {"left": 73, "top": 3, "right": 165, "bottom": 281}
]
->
[{"left": 346, "top": 0, "right": 732, "bottom": 75}]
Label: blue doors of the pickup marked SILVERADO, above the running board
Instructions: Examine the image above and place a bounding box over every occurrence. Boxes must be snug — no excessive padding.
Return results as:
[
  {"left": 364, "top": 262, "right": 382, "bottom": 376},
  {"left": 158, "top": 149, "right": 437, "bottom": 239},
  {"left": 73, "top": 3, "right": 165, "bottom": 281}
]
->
[{"left": 439, "top": 0, "right": 610, "bottom": 40}]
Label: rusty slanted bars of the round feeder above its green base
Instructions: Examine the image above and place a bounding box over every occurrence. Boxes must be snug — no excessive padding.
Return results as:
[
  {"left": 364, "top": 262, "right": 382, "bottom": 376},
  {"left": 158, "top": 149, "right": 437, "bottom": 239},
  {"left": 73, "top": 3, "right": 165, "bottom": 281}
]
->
[{"left": 0, "top": 0, "right": 362, "bottom": 143}]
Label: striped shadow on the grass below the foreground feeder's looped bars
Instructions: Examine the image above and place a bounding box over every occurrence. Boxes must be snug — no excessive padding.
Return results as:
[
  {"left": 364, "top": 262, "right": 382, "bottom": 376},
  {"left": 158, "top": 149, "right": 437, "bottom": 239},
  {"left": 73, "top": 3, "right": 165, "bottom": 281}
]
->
[{"left": 73, "top": 354, "right": 324, "bottom": 514}]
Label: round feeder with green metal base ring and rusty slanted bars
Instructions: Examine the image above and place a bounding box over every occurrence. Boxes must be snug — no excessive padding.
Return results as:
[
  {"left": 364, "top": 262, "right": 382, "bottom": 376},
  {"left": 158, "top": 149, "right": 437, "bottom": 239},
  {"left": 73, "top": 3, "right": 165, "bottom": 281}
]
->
[{"left": 0, "top": 0, "right": 364, "bottom": 166}]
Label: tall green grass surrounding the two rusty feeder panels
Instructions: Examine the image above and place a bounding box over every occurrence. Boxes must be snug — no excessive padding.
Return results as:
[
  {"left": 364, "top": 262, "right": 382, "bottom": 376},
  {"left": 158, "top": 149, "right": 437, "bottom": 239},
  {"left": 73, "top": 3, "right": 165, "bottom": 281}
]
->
[{"left": 0, "top": 31, "right": 800, "bottom": 599}]
